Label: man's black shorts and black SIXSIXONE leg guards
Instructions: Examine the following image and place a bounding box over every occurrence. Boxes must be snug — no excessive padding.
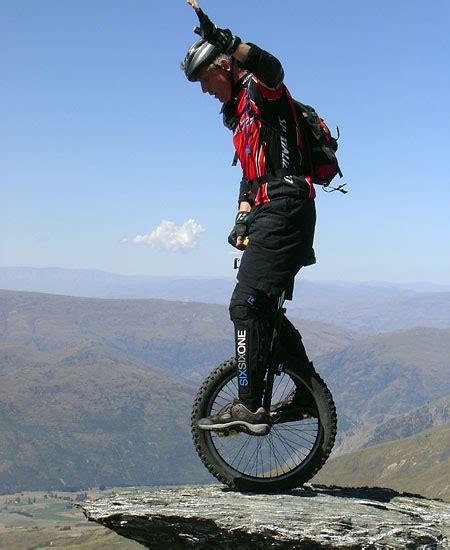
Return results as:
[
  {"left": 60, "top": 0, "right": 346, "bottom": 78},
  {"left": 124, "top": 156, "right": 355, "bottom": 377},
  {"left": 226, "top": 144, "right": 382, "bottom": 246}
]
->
[{"left": 230, "top": 198, "right": 316, "bottom": 410}]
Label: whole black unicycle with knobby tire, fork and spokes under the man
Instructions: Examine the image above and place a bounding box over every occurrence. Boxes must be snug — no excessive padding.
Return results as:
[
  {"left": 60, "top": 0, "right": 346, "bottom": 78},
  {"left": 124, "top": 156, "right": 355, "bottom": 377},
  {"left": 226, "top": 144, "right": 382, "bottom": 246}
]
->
[{"left": 191, "top": 296, "right": 337, "bottom": 493}]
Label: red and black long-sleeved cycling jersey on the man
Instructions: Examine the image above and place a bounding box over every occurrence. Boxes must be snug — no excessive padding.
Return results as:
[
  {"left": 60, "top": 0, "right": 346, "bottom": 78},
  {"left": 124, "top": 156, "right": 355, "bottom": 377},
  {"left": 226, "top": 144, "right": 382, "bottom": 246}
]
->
[{"left": 223, "top": 45, "right": 315, "bottom": 206}]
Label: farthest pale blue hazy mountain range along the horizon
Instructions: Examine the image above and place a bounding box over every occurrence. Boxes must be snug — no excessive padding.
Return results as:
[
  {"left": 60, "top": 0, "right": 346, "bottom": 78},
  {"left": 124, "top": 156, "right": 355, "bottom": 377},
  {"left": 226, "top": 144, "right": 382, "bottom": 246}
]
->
[{"left": 0, "top": 267, "right": 450, "bottom": 332}]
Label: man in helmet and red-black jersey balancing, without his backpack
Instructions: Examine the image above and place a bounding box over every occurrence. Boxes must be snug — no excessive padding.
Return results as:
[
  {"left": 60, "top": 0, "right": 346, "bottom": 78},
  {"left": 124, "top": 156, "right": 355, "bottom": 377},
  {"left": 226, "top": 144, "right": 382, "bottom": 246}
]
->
[{"left": 182, "top": 0, "right": 316, "bottom": 435}]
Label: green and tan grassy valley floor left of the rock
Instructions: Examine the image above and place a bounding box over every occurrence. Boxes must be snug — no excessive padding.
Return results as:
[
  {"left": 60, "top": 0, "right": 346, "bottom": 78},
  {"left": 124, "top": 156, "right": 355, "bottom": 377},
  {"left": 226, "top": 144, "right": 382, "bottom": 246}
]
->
[{"left": 0, "top": 490, "right": 143, "bottom": 550}]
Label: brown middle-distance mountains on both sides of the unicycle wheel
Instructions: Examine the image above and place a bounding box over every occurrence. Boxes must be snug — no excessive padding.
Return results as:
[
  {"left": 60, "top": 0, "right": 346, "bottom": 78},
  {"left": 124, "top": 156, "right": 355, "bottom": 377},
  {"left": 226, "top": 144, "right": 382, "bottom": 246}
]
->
[{"left": 0, "top": 291, "right": 450, "bottom": 492}]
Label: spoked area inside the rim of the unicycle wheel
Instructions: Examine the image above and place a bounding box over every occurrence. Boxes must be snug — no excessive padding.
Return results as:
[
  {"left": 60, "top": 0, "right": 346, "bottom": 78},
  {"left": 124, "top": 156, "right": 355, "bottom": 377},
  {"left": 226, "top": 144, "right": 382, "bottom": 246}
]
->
[{"left": 205, "top": 372, "right": 321, "bottom": 480}]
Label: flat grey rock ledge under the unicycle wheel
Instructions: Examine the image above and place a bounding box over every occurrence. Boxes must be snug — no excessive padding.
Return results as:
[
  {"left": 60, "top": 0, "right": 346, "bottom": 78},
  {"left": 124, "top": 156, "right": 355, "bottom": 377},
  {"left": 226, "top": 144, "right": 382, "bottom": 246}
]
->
[{"left": 79, "top": 485, "right": 450, "bottom": 550}]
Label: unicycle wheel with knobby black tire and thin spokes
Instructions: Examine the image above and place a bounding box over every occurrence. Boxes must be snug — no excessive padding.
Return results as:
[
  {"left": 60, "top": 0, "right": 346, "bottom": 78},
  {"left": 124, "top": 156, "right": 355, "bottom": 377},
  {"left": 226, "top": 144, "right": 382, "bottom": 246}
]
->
[{"left": 191, "top": 358, "right": 337, "bottom": 493}]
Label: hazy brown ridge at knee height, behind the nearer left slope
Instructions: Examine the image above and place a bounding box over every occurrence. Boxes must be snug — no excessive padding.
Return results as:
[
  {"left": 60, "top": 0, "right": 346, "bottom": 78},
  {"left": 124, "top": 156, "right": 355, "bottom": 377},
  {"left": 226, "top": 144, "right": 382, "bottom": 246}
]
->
[{"left": 0, "top": 290, "right": 356, "bottom": 383}]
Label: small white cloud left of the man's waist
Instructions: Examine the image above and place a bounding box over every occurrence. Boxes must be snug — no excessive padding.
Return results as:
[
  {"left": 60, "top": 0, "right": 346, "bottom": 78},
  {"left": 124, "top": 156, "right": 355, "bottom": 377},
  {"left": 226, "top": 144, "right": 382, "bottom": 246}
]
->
[{"left": 120, "top": 218, "right": 205, "bottom": 252}]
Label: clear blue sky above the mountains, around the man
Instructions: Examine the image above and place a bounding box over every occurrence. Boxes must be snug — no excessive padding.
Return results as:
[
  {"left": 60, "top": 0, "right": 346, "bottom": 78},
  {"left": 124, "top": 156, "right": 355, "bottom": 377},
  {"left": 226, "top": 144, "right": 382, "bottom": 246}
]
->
[{"left": 0, "top": 0, "right": 450, "bottom": 283}]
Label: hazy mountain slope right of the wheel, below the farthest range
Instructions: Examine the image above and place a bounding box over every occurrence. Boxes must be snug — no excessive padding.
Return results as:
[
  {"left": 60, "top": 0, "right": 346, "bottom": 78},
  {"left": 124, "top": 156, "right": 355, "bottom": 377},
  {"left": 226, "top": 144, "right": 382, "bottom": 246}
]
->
[{"left": 316, "top": 328, "right": 450, "bottom": 424}]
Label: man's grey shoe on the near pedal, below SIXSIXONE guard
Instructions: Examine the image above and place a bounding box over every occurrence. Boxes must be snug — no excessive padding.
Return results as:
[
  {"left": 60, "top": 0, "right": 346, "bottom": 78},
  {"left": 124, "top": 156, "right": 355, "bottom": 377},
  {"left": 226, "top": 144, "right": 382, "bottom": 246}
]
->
[{"left": 197, "top": 399, "right": 270, "bottom": 435}]
